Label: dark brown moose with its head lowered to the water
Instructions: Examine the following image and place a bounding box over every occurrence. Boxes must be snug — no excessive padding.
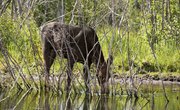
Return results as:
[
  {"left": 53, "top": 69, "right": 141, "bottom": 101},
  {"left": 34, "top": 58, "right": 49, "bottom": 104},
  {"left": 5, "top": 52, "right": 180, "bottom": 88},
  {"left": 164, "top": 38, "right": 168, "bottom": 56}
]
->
[{"left": 41, "top": 22, "right": 113, "bottom": 93}]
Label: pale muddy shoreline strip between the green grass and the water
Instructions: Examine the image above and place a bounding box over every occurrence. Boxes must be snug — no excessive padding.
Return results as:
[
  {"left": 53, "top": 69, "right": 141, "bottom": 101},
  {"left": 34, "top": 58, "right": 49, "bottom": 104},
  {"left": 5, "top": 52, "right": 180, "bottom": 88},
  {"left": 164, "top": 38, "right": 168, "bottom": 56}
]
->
[{"left": 0, "top": 74, "right": 180, "bottom": 87}]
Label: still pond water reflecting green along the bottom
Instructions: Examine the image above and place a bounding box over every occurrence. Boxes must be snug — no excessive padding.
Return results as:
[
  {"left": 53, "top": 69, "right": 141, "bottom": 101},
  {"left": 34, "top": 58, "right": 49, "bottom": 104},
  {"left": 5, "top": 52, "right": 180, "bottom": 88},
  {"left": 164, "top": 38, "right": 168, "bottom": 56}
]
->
[{"left": 0, "top": 86, "right": 180, "bottom": 110}]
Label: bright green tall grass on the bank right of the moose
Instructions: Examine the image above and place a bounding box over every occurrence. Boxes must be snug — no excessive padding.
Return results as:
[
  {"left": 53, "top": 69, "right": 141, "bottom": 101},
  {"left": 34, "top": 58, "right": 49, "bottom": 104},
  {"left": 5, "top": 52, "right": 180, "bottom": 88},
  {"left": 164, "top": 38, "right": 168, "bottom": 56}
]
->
[{"left": 97, "top": 27, "right": 180, "bottom": 73}]
